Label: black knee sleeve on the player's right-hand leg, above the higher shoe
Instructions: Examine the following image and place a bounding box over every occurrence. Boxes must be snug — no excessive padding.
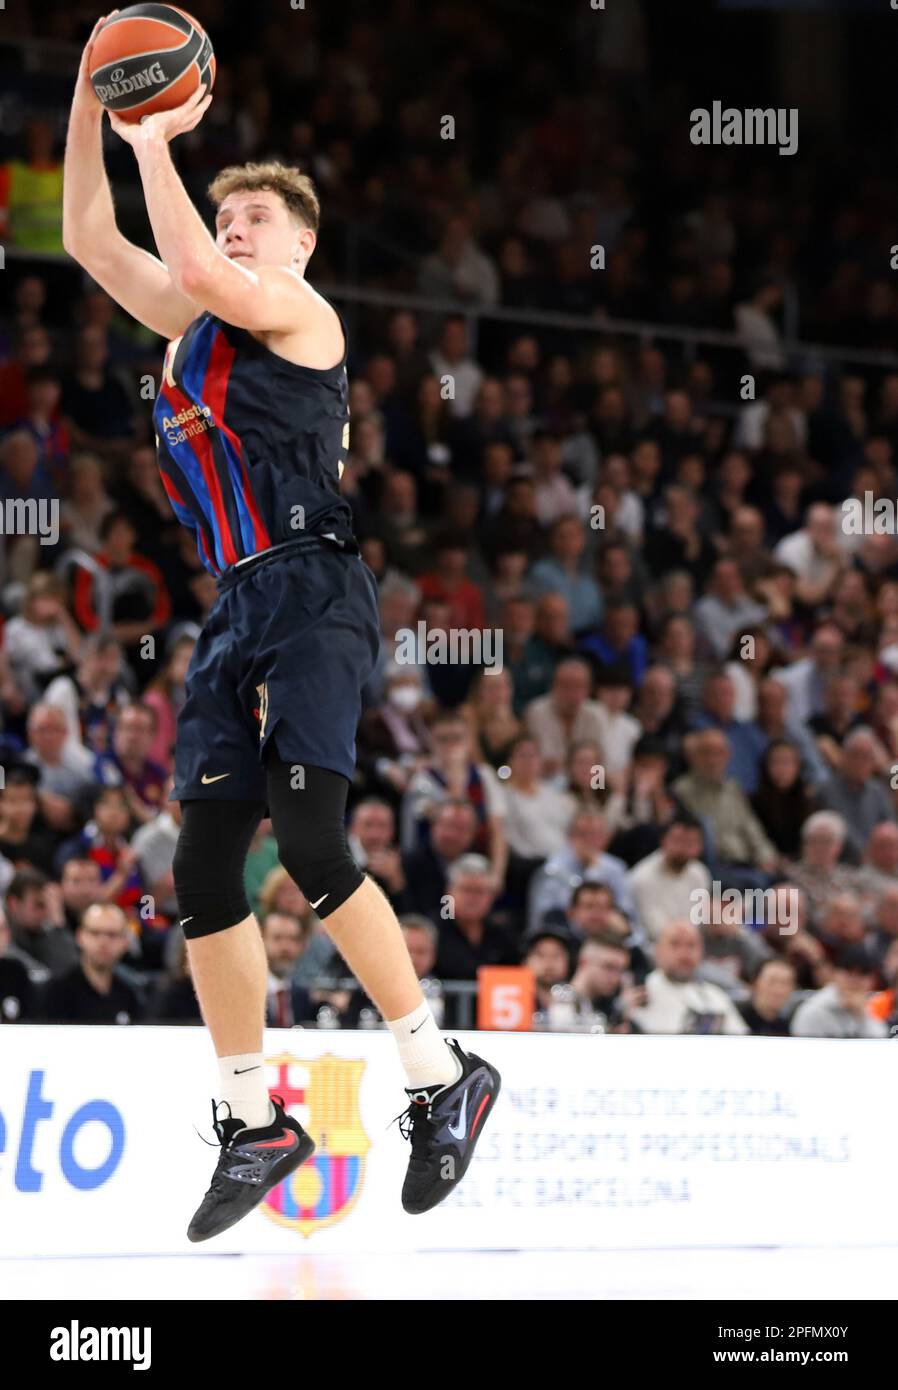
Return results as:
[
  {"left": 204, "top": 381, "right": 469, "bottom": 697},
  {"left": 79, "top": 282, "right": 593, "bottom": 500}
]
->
[{"left": 266, "top": 755, "right": 364, "bottom": 917}]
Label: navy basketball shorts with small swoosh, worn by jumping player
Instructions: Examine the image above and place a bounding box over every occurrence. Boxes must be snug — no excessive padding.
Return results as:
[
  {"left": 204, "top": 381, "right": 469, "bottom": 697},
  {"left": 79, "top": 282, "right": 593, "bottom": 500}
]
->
[{"left": 171, "top": 537, "right": 381, "bottom": 802}]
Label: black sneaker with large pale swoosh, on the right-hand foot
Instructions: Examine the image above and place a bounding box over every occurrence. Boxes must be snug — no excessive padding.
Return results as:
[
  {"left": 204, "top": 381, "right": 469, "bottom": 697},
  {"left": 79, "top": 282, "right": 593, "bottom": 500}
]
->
[{"left": 396, "top": 1038, "right": 502, "bottom": 1215}]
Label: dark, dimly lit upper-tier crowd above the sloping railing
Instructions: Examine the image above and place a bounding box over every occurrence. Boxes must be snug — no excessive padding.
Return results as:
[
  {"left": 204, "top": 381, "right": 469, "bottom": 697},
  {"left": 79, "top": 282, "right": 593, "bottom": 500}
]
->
[{"left": 0, "top": 0, "right": 898, "bottom": 353}]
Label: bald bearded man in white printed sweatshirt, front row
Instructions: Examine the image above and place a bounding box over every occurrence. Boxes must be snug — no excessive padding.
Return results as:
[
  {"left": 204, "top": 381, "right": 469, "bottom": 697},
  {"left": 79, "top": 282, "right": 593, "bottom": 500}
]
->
[{"left": 628, "top": 920, "right": 748, "bottom": 1034}]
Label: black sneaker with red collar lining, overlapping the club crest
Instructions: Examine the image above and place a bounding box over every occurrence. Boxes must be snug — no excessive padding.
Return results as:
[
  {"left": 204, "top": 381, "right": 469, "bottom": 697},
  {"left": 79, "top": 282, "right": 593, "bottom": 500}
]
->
[{"left": 188, "top": 1095, "right": 316, "bottom": 1241}]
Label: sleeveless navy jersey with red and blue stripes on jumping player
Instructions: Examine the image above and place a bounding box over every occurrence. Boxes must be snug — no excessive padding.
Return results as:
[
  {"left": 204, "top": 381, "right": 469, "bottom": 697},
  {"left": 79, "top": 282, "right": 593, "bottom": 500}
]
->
[{"left": 153, "top": 313, "right": 353, "bottom": 574}]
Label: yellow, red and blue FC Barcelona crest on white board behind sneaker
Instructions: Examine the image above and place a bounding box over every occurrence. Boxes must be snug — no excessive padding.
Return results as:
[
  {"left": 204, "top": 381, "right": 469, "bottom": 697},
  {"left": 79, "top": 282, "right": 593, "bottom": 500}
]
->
[{"left": 260, "top": 1052, "right": 371, "bottom": 1236}]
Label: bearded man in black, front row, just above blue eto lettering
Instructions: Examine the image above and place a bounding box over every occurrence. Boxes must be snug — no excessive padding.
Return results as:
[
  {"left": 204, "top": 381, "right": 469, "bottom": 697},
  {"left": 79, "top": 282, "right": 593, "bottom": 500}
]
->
[{"left": 42, "top": 902, "right": 145, "bottom": 1023}]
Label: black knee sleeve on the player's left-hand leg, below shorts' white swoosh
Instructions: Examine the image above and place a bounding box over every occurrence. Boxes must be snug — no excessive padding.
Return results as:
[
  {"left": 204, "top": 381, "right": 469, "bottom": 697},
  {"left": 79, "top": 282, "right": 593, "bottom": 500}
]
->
[{"left": 172, "top": 801, "right": 266, "bottom": 937}]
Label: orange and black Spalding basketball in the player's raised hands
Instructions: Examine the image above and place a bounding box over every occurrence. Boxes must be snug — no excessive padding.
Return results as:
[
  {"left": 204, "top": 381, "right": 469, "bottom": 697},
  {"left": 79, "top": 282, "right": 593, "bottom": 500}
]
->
[{"left": 90, "top": 4, "right": 215, "bottom": 122}]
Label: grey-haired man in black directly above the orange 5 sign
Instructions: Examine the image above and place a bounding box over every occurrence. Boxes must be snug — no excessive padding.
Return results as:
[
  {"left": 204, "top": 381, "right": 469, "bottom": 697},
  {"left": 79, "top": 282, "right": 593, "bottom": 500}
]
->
[{"left": 436, "top": 855, "right": 519, "bottom": 980}]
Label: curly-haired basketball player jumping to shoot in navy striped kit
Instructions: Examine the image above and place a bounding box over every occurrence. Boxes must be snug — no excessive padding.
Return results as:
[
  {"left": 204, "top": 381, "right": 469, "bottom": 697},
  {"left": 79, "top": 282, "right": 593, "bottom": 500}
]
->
[{"left": 64, "top": 19, "right": 499, "bottom": 1241}]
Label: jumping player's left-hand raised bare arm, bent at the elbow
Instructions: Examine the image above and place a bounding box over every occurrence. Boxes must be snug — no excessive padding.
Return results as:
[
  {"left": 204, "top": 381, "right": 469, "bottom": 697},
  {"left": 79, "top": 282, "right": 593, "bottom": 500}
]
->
[{"left": 63, "top": 11, "right": 199, "bottom": 338}]
